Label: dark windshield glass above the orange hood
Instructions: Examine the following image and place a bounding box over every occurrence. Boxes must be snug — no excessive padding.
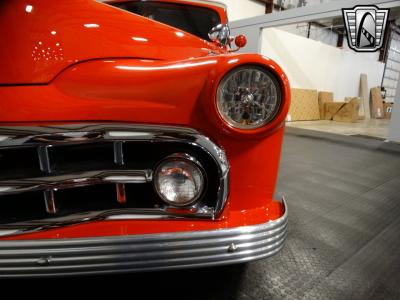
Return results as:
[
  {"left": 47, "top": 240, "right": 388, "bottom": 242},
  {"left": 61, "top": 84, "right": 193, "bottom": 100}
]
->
[{"left": 110, "top": 1, "right": 221, "bottom": 41}]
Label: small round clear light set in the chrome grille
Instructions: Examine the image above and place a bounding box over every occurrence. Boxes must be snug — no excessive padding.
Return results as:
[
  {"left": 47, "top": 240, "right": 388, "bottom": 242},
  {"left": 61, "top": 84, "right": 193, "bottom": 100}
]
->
[{"left": 154, "top": 156, "right": 204, "bottom": 207}]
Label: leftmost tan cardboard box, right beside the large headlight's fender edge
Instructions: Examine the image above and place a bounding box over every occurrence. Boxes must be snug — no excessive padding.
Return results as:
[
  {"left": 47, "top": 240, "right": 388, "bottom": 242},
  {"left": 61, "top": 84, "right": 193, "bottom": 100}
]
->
[{"left": 287, "top": 89, "right": 320, "bottom": 121}]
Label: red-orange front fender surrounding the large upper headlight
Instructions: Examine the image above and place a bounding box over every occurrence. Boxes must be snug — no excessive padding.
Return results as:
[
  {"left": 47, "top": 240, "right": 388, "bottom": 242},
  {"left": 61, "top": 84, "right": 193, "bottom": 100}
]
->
[{"left": 0, "top": 54, "right": 290, "bottom": 222}]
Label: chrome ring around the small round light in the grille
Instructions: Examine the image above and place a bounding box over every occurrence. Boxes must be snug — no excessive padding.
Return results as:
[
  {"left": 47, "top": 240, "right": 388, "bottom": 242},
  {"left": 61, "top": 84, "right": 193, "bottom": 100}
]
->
[{"left": 153, "top": 153, "right": 207, "bottom": 208}]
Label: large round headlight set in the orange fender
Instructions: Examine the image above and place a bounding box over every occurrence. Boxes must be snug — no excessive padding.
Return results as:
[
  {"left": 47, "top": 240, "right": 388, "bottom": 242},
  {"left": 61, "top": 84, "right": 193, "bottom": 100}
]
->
[{"left": 217, "top": 66, "right": 281, "bottom": 129}]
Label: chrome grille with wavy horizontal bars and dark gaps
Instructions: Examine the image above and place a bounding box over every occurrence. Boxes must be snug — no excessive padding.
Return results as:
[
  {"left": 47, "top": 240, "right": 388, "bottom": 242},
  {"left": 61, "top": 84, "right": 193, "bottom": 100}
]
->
[{"left": 0, "top": 124, "right": 229, "bottom": 235}]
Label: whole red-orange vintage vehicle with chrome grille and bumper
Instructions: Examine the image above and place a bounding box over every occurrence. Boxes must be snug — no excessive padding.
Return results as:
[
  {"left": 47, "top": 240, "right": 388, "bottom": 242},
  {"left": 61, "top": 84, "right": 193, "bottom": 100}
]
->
[{"left": 0, "top": 0, "right": 290, "bottom": 277}]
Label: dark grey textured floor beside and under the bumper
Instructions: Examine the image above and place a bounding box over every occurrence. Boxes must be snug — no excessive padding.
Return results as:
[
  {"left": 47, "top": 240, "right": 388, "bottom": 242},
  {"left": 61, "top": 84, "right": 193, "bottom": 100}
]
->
[{"left": 21, "top": 128, "right": 400, "bottom": 299}]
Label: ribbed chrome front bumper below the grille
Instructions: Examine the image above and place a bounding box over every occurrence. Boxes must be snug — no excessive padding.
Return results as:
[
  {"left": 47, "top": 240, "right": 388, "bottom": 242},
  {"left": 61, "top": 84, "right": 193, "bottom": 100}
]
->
[{"left": 0, "top": 202, "right": 288, "bottom": 278}]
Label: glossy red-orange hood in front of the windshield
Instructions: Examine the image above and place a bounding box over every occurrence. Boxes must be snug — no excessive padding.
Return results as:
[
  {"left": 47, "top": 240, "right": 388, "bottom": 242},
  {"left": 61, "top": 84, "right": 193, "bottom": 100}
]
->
[{"left": 0, "top": 0, "right": 222, "bottom": 84}]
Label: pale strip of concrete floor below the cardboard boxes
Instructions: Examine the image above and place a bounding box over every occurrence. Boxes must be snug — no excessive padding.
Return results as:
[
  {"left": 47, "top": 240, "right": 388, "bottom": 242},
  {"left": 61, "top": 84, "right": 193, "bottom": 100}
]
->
[{"left": 286, "top": 119, "right": 390, "bottom": 139}]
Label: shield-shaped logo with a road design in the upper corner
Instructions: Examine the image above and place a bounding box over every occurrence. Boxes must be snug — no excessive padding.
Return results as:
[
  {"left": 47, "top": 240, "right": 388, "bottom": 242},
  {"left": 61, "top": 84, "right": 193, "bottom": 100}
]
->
[{"left": 342, "top": 5, "right": 389, "bottom": 52}]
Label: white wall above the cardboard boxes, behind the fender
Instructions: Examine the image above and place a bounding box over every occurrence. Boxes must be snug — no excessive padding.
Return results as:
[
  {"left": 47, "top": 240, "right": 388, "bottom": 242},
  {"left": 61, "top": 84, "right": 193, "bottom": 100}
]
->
[{"left": 261, "top": 28, "right": 384, "bottom": 101}]
